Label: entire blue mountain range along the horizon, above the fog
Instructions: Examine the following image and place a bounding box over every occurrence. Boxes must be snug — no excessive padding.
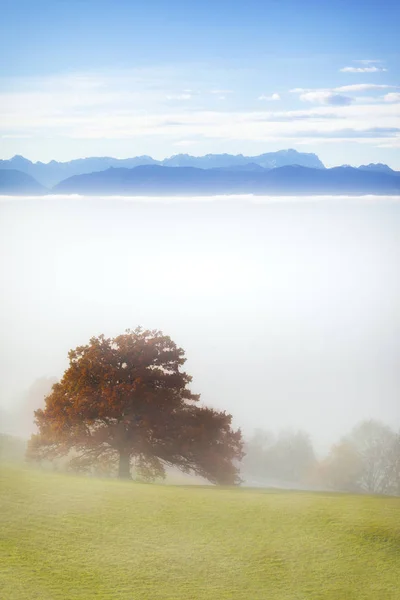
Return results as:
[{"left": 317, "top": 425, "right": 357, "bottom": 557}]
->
[{"left": 0, "top": 150, "right": 400, "bottom": 196}]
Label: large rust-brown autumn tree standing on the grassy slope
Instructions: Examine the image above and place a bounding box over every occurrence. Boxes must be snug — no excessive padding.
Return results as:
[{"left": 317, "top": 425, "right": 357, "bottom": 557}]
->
[{"left": 28, "top": 328, "right": 243, "bottom": 484}]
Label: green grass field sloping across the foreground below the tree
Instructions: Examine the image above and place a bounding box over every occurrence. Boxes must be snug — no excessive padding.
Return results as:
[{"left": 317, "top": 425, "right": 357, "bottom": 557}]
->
[{"left": 0, "top": 467, "right": 400, "bottom": 600}]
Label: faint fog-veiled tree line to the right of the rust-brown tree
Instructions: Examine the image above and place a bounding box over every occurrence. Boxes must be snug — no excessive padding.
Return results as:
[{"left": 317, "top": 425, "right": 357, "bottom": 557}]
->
[{"left": 241, "top": 420, "right": 400, "bottom": 495}]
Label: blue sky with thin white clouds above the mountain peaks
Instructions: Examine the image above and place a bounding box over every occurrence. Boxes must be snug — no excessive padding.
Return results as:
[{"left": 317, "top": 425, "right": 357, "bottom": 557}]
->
[{"left": 0, "top": 0, "right": 400, "bottom": 170}]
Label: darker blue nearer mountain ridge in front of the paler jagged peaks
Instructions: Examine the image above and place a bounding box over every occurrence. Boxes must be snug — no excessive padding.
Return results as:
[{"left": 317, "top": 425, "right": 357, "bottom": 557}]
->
[{"left": 53, "top": 165, "right": 400, "bottom": 196}]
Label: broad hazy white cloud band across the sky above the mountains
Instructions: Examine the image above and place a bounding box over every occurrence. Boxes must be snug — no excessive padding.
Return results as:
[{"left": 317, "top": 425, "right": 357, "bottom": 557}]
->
[{"left": 0, "top": 73, "right": 400, "bottom": 147}]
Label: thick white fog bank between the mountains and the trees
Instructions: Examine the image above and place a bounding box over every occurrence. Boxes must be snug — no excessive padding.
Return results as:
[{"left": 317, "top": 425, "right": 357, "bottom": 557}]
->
[{"left": 0, "top": 197, "right": 400, "bottom": 449}]
